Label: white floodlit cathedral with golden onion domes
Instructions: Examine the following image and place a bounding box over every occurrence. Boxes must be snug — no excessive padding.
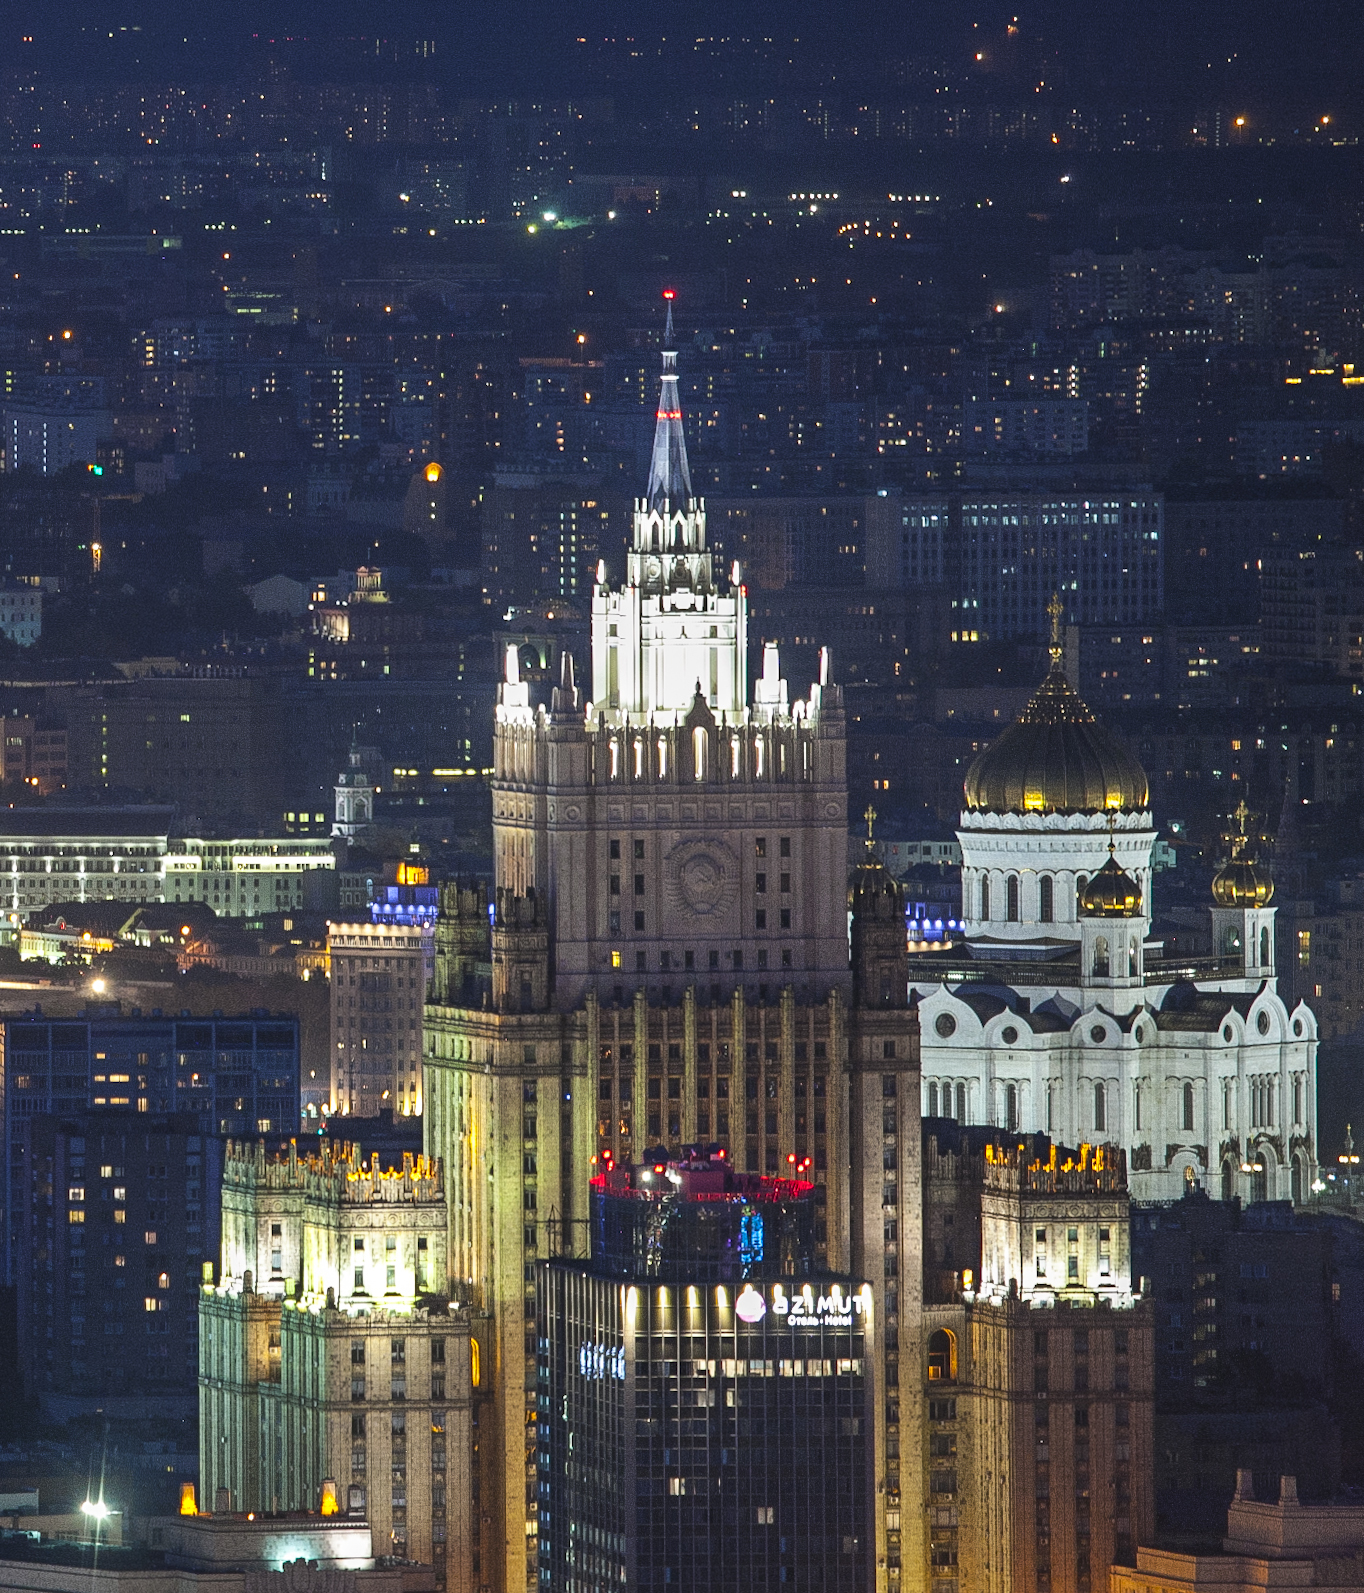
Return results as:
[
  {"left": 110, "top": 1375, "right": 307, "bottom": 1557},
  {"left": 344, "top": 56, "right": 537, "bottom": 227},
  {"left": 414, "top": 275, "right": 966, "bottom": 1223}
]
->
[{"left": 910, "top": 618, "right": 1316, "bottom": 1201}]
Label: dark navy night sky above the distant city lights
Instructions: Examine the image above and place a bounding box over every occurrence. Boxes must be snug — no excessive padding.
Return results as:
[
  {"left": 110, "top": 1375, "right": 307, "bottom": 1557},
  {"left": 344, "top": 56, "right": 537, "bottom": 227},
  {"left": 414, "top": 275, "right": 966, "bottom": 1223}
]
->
[{"left": 0, "top": 0, "right": 1364, "bottom": 104}]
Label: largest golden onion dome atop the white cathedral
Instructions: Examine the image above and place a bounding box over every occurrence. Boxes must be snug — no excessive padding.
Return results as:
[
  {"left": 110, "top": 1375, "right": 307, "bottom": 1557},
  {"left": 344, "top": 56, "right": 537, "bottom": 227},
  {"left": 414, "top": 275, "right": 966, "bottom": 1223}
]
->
[{"left": 964, "top": 658, "right": 1149, "bottom": 812}]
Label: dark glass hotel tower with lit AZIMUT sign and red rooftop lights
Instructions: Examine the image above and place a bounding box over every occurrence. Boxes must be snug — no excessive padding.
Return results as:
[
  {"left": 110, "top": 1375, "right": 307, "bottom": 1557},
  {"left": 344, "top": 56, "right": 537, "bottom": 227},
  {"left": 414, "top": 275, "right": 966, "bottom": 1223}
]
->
[{"left": 537, "top": 1152, "right": 875, "bottom": 1593}]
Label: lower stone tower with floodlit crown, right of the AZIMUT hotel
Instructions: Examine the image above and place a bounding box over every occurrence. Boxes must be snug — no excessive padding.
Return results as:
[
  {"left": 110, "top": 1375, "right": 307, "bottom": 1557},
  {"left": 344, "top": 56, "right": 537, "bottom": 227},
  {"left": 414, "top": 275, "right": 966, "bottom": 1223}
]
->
[{"left": 900, "top": 1120, "right": 1155, "bottom": 1593}]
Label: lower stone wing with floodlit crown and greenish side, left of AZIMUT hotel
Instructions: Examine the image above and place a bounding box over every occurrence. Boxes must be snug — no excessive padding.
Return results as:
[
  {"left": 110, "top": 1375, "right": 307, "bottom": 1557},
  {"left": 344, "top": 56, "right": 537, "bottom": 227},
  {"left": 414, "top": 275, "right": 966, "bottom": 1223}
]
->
[{"left": 199, "top": 1141, "right": 483, "bottom": 1593}]
